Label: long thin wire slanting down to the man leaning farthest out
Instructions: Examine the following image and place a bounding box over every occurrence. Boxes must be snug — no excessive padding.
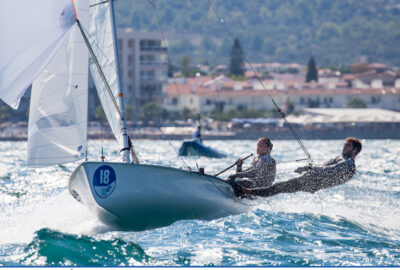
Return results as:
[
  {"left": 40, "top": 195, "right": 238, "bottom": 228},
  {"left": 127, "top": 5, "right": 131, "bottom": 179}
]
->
[{"left": 208, "top": 0, "right": 314, "bottom": 163}]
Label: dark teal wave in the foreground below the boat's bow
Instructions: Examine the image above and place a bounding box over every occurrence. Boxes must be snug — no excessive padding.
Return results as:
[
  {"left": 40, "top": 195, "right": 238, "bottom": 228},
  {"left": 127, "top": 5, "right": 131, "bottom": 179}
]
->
[{"left": 20, "top": 228, "right": 155, "bottom": 266}]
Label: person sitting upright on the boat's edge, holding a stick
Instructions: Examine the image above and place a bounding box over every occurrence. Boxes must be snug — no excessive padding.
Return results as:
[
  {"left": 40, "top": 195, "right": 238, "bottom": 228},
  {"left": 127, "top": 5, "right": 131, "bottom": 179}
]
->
[{"left": 229, "top": 138, "right": 276, "bottom": 188}]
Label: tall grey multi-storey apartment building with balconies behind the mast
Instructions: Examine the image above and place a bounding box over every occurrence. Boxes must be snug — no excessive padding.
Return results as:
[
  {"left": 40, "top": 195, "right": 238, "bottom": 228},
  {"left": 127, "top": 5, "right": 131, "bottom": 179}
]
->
[{"left": 117, "top": 28, "right": 168, "bottom": 110}]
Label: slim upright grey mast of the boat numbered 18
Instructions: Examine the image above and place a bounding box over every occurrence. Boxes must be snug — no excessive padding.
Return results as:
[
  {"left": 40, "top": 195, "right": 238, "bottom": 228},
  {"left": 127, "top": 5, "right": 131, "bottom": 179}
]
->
[{"left": 108, "top": 0, "right": 130, "bottom": 163}]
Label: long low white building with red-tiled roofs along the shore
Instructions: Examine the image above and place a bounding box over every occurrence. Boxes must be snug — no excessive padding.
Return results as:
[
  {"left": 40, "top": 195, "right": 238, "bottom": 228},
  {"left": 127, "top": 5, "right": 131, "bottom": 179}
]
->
[{"left": 163, "top": 77, "right": 400, "bottom": 113}]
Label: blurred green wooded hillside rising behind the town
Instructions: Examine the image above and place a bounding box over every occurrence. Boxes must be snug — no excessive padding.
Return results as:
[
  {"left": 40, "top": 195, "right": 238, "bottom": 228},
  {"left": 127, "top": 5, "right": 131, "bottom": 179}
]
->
[{"left": 116, "top": 0, "right": 400, "bottom": 66}]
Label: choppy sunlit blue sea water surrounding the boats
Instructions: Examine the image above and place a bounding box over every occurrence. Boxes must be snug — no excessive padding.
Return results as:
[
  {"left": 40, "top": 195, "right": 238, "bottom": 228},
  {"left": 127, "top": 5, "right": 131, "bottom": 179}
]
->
[{"left": 0, "top": 140, "right": 400, "bottom": 266}]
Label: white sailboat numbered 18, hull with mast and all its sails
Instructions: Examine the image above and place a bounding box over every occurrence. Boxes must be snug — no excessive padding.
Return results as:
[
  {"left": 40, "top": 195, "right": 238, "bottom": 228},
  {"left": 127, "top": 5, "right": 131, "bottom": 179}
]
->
[{"left": 0, "top": 0, "right": 249, "bottom": 230}]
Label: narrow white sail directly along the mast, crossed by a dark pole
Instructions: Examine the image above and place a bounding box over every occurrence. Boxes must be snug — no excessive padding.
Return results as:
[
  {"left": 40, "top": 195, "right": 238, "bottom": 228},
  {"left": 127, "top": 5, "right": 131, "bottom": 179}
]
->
[{"left": 89, "top": 0, "right": 124, "bottom": 151}]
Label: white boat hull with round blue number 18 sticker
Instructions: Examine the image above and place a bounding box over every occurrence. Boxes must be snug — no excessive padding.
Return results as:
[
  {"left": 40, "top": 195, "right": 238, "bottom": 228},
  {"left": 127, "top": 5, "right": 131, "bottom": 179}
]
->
[{"left": 68, "top": 162, "right": 248, "bottom": 230}]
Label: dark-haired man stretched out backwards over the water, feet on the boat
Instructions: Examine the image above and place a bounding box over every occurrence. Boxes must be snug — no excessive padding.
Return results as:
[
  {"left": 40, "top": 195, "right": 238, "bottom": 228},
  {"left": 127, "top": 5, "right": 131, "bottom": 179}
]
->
[{"left": 231, "top": 137, "right": 362, "bottom": 197}]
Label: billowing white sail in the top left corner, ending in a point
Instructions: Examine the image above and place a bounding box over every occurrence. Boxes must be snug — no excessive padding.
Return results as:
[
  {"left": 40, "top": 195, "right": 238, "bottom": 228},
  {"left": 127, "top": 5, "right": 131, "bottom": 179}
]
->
[{"left": 0, "top": 0, "right": 75, "bottom": 108}]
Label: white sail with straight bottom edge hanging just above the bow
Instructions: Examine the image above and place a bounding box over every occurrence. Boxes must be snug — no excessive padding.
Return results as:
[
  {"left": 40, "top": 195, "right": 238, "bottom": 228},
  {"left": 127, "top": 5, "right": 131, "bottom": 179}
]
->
[{"left": 28, "top": 0, "right": 89, "bottom": 166}]
